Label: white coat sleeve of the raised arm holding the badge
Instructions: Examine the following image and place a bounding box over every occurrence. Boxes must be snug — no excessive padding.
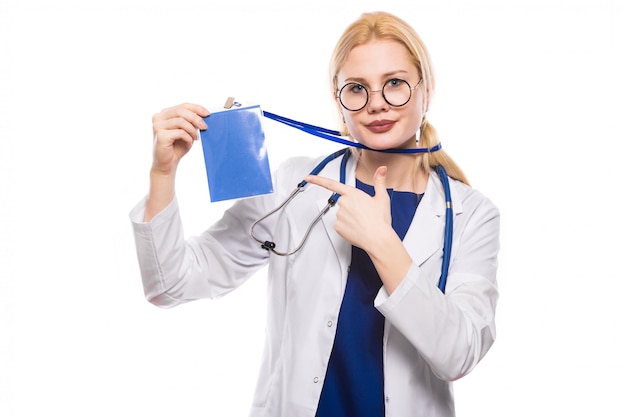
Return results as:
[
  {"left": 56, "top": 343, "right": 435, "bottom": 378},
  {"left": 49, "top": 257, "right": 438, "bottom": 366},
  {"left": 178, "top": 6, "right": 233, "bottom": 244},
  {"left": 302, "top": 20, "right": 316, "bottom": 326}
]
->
[{"left": 130, "top": 190, "right": 273, "bottom": 307}]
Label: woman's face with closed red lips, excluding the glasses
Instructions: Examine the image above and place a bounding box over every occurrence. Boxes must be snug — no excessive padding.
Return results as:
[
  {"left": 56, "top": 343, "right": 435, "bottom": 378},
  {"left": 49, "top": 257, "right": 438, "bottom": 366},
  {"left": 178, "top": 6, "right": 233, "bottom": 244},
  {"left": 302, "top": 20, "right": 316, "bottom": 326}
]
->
[{"left": 337, "top": 40, "right": 424, "bottom": 149}]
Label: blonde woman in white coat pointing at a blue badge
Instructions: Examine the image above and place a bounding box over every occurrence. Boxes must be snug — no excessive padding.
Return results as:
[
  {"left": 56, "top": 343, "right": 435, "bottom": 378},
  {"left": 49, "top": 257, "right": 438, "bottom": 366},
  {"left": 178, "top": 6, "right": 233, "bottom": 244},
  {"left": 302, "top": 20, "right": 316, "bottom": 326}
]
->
[{"left": 131, "top": 13, "right": 499, "bottom": 417}]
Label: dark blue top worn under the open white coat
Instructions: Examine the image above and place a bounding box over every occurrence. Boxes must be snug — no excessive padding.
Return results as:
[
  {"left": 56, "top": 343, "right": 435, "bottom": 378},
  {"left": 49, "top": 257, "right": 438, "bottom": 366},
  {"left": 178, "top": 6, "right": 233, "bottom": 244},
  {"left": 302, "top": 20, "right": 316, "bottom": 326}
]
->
[{"left": 316, "top": 180, "right": 423, "bottom": 417}]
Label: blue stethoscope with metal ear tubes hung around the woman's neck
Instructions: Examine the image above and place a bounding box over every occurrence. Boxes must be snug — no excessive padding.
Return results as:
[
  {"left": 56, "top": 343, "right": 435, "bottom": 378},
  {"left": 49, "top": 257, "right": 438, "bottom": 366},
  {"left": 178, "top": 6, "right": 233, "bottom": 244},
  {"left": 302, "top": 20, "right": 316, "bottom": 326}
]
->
[{"left": 250, "top": 142, "right": 453, "bottom": 294}]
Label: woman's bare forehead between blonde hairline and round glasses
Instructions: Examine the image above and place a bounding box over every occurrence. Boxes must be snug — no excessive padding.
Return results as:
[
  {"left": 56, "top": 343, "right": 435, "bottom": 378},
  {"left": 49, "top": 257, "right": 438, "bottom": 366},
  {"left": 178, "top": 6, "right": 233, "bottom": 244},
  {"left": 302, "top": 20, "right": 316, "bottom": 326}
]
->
[{"left": 337, "top": 39, "right": 417, "bottom": 80}]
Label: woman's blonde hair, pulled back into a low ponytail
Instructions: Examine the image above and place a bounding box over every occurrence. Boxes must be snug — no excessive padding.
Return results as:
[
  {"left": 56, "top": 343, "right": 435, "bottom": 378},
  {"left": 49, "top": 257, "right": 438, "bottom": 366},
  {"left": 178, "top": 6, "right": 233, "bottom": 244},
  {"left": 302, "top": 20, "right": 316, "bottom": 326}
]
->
[{"left": 330, "top": 12, "right": 469, "bottom": 185}]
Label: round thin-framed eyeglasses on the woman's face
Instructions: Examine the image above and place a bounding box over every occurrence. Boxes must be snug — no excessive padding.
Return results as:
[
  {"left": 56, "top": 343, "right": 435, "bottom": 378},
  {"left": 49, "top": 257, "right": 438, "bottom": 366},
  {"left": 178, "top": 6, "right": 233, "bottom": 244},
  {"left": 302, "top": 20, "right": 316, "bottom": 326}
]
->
[{"left": 337, "top": 78, "right": 422, "bottom": 111}]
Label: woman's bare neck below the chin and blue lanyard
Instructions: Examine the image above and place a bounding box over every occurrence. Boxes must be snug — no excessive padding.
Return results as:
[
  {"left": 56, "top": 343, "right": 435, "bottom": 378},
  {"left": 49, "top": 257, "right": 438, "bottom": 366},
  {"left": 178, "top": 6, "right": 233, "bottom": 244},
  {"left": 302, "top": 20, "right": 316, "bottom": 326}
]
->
[{"left": 356, "top": 150, "right": 428, "bottom": 194}]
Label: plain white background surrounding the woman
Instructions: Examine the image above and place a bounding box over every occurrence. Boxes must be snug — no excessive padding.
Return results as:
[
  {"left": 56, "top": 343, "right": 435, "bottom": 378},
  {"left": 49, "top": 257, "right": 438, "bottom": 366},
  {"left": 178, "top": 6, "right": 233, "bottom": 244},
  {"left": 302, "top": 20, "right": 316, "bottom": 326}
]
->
[{"left": 0, "top": 0, "right": 626, "bottom": 417}]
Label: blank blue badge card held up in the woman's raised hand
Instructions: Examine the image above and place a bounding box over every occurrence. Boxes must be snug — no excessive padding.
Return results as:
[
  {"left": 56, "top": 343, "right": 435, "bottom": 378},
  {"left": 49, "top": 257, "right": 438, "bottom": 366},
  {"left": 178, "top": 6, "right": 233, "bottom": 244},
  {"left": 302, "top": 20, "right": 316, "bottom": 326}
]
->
[{"left": 200, "top": 105, "right": 274, "bottom": 202}]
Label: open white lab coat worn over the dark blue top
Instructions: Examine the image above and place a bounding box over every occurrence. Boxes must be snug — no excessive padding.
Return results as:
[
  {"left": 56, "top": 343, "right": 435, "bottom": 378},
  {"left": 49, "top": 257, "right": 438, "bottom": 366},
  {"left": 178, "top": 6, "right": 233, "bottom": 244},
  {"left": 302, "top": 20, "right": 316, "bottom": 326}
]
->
[{"left": 131, "top": 153, "right": 499, "bottom": 417}]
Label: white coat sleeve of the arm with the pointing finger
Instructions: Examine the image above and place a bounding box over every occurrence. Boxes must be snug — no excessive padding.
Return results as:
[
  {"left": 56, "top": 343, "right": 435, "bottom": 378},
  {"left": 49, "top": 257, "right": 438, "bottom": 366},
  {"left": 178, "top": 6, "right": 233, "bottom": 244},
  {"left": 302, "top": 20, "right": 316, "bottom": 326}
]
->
[{"left": 375, "top": 192, "right": 500, "bottom": 381}]
